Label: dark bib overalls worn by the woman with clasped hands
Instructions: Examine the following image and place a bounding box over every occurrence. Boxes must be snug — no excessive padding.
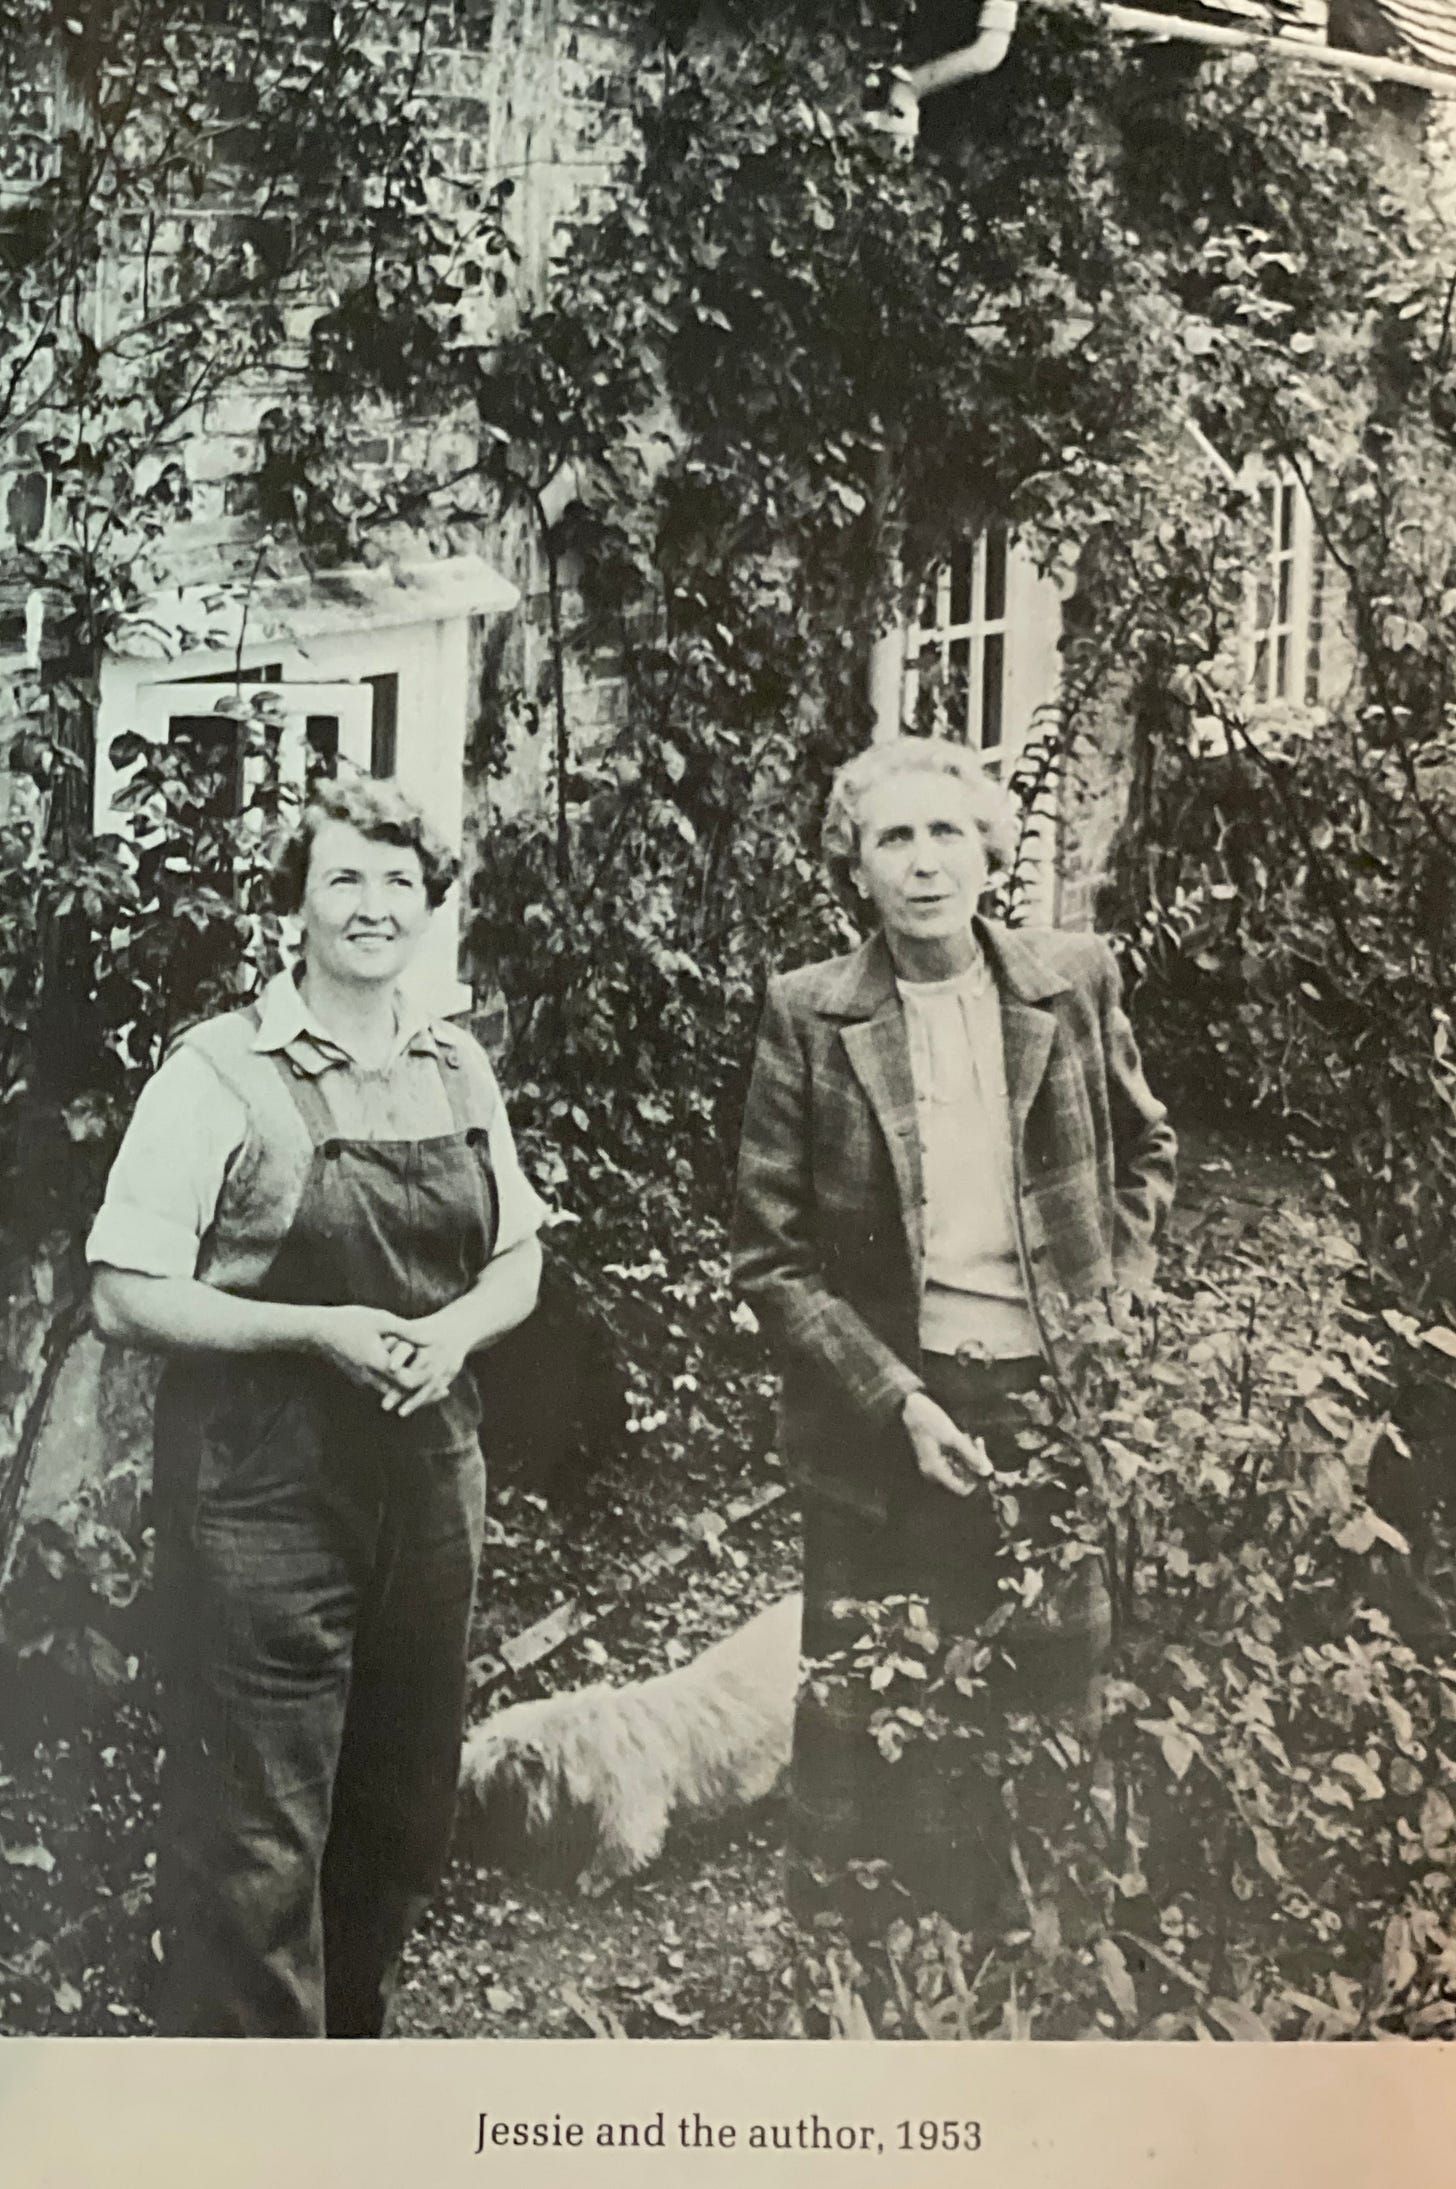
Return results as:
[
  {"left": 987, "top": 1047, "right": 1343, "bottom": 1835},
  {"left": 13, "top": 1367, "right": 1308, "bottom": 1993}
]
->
[{"left": 155, "top": 1020, "right": 497, "bottom": 2036}]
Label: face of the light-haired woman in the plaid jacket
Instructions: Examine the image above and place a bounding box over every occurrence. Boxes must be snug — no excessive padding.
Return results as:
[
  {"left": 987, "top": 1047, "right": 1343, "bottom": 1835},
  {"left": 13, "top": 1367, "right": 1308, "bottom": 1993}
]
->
[{"left": 854, "top": 768, "right": 990, "bottom": 978}]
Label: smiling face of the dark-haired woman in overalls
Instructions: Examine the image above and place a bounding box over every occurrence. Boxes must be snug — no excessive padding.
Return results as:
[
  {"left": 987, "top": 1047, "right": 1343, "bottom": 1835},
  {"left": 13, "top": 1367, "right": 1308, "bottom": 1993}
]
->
[{"left": 300, "top": 821, "right": 429, "bottom": 987}]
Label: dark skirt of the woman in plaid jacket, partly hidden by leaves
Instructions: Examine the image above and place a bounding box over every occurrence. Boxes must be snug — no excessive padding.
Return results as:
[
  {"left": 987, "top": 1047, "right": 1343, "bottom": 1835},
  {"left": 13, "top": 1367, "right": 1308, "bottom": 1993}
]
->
[{"left": 788, "top": 1357, "right": 1110, "bottom": 1931}]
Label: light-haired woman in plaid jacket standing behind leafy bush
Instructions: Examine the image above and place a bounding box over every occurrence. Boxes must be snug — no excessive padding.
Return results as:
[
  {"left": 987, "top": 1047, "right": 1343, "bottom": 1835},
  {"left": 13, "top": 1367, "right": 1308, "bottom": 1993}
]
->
[{"left": 733, "top": 738, "right": 1176, "bottom": 1922}]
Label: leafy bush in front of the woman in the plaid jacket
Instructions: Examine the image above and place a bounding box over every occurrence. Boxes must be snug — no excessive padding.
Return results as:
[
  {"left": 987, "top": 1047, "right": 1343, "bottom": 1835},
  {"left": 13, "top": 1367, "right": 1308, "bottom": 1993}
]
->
[{"left": 795, "top": 1215, "right": 1456, "bottom": 2040}]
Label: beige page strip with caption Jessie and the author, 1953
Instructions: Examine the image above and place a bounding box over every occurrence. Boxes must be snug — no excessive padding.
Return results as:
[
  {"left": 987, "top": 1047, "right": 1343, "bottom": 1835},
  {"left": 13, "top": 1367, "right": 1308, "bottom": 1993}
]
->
[{"left": 0, "top": 2038, "right": 1456, "bottom": 2189}]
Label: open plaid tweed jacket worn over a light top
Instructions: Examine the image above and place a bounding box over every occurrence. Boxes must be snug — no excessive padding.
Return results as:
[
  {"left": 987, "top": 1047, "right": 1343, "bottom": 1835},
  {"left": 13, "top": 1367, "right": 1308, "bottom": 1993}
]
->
[{"left": 731, "top": 919, "right": 1176, "bottom": 1510}]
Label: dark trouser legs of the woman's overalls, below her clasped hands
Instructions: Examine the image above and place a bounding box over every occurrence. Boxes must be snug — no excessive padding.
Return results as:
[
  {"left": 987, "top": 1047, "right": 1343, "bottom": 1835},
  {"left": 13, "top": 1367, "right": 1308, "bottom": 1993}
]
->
[{"left": 158, "top": 1383, "right": 484, "bottom": 2036}]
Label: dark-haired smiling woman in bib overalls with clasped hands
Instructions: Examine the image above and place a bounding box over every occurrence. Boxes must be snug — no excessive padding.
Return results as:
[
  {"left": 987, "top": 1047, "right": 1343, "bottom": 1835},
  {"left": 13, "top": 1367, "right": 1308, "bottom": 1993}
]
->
[{"left": 88, "top": 784, "right": 541, "bottom": 2036}]
